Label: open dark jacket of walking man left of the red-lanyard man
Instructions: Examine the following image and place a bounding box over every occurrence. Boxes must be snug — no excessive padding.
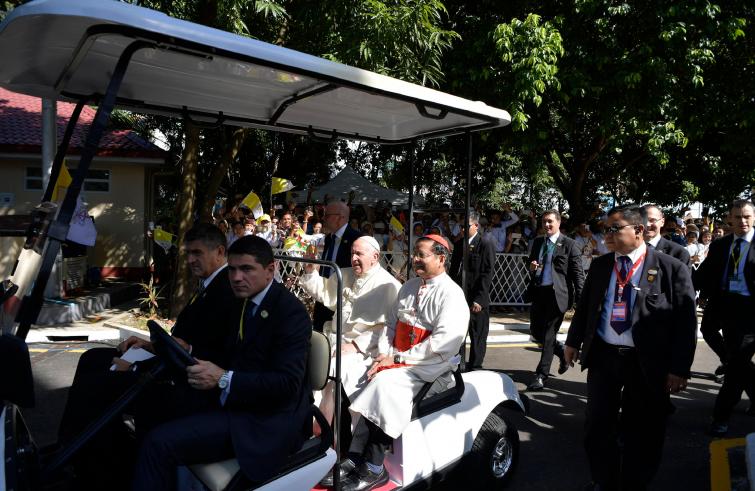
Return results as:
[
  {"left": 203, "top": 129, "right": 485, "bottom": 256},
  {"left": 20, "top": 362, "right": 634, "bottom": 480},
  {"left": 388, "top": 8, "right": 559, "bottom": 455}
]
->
[{"left": 528, "top": 234, "right": 585, "bottom": 312}]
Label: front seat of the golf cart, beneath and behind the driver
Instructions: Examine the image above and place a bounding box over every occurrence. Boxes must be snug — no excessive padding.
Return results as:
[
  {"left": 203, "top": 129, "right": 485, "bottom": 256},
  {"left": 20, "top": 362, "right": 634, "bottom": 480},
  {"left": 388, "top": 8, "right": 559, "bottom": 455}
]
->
[{"left": 189, "top": 331, "right": 335, "bottom": 491}]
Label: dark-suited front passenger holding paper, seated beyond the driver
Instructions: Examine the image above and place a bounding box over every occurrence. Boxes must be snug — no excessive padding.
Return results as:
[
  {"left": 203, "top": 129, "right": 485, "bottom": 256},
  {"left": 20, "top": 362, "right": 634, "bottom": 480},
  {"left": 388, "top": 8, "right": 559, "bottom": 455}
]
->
[{"left": 58, "top": 224, "right": 235, "bottom": 488}]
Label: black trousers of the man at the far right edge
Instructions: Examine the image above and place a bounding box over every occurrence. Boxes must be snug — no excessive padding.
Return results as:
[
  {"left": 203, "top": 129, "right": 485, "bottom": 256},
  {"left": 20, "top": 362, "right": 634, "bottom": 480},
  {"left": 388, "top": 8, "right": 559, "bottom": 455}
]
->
[{"left": 713, "top": 294, "right": 755, "bottom": 422}]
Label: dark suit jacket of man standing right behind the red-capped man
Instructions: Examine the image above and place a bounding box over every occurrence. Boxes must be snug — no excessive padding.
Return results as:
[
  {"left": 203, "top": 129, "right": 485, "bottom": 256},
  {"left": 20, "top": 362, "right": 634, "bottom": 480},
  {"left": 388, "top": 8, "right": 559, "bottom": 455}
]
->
[{"left": 450, "top": 232, "right": 496, "bottom": 308}]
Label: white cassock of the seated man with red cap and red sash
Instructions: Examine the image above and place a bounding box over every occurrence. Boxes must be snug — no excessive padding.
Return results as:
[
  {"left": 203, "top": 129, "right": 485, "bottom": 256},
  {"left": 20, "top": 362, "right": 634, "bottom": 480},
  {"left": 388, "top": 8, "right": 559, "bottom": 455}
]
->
[{"left": 349, "top": 273, "right": 469, "bottom": 438}]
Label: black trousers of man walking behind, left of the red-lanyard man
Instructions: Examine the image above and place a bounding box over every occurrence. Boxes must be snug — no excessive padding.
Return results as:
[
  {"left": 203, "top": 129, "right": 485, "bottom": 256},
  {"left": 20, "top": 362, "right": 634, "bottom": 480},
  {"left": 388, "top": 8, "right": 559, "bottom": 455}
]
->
[{"left": 530, "top": 286, "right": 564, "bottom": 377}]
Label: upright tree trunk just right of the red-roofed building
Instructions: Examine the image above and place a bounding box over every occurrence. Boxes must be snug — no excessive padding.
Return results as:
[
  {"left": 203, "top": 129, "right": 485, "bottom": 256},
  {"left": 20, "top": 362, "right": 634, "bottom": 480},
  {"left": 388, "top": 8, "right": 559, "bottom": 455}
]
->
[{"left": 170, "top": 120, "right": 199, "bottom": 318}]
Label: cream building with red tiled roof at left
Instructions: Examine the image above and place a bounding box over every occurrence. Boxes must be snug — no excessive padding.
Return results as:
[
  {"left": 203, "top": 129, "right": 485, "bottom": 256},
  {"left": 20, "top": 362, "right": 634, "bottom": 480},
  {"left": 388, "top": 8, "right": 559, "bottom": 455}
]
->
[{"left": 0, "top": 88, "right": 167, "bottom": 286}]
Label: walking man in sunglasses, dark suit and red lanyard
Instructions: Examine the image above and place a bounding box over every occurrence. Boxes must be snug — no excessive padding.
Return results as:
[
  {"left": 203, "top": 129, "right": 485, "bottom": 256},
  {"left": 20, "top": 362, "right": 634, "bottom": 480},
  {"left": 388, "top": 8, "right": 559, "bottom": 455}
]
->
[{"left": 564, "top": 207, "right": 697, "bottom": 491}]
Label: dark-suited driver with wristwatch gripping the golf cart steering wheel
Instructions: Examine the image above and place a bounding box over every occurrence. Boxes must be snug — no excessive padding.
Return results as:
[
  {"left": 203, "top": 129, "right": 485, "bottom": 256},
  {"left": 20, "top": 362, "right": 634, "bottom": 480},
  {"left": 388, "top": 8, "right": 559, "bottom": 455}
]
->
[{"left": 133, "top": 236, "right": 312, "bottom": 491}]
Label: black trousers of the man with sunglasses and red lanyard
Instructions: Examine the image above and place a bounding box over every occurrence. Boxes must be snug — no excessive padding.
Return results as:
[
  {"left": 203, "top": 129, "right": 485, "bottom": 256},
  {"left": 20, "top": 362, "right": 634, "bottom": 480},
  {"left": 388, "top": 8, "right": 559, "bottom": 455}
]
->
[{"left": 585, "top": 335, "right": 670, "bottom": 491}]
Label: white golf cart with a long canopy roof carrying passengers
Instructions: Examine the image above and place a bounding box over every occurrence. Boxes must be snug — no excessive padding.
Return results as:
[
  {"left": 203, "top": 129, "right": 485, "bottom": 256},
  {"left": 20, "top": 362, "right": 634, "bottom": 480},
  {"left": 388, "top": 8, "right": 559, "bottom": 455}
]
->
[{"left": 0, "top": 0, "right": 525, "bottom": 490}]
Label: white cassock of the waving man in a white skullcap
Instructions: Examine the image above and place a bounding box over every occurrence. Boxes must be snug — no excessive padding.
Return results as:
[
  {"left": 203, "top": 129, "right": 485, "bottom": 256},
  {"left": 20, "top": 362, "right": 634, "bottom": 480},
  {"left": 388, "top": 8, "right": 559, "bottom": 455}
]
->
[{"left": 299, "top": 264, "right": 401, "bottom": 418}]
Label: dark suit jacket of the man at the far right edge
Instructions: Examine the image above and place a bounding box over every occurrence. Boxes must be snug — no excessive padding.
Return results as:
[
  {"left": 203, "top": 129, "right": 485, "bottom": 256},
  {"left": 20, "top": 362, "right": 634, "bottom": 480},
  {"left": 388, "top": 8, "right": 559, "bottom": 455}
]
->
[{"left": 693, "top": 234, "right": 755, "bottom": 302}]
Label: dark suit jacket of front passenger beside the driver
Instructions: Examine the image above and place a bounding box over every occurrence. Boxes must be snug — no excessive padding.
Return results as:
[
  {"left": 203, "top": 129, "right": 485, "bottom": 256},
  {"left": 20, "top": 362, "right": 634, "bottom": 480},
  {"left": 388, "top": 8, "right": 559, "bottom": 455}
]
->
[{"left": 172, "top": 267, "right": 237, "bottom": 367}]
